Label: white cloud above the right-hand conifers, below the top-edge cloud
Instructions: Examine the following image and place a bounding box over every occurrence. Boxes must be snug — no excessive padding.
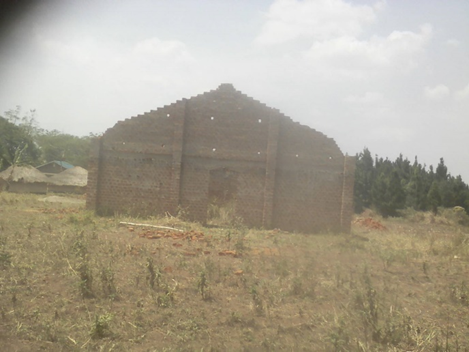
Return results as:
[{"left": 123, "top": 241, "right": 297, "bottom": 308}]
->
[{"left": 306, "top": 25, "right": 432, "bottom": 70}]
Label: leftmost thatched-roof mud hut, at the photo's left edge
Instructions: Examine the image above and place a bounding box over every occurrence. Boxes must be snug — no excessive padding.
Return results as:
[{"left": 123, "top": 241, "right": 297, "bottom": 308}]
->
[{"left": 0, "top": 165, "right": 49, "bottom": 193}]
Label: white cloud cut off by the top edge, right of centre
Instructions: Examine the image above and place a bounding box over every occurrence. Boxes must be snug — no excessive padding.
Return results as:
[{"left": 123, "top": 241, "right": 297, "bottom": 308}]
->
[{"left": 256, "top": 0, "right": 378, "bottom": 45}]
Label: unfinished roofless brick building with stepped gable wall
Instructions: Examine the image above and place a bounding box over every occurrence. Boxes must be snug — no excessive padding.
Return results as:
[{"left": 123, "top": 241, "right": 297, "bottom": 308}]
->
[{"left": 87, "top": 84, "right": 355, "bottom": 232}]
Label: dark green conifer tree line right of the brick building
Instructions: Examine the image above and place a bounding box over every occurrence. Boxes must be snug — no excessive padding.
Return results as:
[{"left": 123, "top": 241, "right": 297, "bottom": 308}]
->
[{"left": 354, "top": 148, "right": 469, "bottom": 217}]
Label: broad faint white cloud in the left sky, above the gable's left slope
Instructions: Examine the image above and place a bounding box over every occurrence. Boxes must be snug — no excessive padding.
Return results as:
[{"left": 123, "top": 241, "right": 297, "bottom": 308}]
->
[{"left": 37, "top": 35, "right": 194, "bottom": 89}]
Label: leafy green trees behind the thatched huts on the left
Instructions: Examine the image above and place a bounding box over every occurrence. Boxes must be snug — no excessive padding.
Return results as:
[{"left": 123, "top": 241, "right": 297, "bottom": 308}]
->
[{"left": 0, "top": 106, "right": 94, "bottom": 171}]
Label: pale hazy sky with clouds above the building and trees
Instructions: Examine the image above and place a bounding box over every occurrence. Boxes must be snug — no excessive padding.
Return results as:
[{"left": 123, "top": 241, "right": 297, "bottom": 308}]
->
[{"left": 0, "top": 0, "right": 469, "bottom": 182}]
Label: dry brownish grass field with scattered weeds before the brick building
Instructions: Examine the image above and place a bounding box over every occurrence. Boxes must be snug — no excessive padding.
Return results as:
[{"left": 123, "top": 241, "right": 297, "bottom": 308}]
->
[{"left": 0, "top": 193, "right": 469, "bottom": 351}]
